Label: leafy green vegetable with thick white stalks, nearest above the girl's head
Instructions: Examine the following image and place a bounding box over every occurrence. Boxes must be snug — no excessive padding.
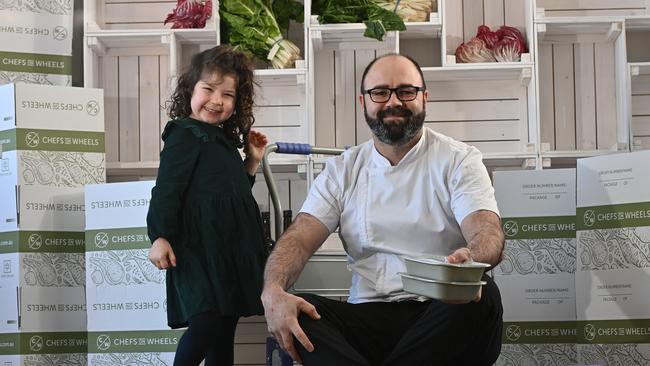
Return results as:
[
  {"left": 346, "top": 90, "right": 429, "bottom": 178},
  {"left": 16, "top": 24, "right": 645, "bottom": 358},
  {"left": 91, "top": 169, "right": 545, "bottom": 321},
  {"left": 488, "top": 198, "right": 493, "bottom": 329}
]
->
[{"left": 219, "top": 0, "right": 300, "bottom": 69}]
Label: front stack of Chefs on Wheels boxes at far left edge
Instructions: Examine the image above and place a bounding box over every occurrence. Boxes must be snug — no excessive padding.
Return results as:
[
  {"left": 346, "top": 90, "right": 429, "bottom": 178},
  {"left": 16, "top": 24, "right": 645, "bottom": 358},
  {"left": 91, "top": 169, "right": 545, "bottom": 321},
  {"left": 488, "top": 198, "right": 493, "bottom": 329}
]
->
[{"left": 0, "top": 84, "right": 106, "bottom": 366}]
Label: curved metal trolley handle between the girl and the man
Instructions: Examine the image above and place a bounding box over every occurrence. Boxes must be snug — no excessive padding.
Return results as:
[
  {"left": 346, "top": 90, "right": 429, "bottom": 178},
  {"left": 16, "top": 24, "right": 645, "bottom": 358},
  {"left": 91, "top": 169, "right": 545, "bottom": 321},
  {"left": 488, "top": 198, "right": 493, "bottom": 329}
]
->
[{"left": 262, "top": 142, "right": 345, "bottom": 240}]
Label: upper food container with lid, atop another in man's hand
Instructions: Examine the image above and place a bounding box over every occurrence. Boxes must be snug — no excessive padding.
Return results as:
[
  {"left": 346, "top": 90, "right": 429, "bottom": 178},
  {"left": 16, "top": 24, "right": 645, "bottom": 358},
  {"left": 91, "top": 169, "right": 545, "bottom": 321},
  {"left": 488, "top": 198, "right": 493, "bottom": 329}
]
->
[{"left": 404, "top": 257, "right": 490, "bottom": 282}]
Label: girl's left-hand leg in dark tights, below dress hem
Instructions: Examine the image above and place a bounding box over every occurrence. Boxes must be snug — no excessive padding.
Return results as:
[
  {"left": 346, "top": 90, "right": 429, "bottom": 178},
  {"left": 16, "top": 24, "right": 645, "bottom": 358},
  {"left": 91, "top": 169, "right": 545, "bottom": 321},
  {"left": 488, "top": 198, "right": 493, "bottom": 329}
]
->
[{"left": 174, "top": 311, "right": 221, "bottom": 366}]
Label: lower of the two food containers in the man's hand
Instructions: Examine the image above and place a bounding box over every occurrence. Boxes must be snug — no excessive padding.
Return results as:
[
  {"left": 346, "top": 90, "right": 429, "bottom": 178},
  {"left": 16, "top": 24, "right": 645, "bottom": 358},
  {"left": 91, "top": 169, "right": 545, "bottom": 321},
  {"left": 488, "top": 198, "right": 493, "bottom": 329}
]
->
[{"left": 400, "top": 273, "right": 487, "bottom": 301}]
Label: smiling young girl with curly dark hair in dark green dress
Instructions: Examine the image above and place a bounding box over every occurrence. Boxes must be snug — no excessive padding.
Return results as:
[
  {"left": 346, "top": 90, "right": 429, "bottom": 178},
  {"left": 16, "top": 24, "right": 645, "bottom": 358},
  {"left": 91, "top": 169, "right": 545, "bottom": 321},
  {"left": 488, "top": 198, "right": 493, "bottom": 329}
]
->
[{"left": 147, "top": 46, "right": 267, "bottom": 366}]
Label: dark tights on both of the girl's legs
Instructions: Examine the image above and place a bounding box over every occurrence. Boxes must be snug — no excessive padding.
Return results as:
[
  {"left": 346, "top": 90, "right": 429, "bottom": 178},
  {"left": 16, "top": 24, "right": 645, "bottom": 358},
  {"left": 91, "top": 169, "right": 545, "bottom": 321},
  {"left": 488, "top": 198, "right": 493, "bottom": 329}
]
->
[{"left": 174, "top": 311, "right": 239, "bottom": 366}]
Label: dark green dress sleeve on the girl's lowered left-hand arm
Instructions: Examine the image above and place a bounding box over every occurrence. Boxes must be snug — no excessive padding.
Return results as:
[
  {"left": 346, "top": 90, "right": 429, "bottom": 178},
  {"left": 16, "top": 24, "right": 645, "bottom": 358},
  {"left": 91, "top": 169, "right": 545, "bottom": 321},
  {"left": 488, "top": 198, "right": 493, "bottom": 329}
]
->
[{"left": 147, "top": 121, "right": 201, "bottom": 248}]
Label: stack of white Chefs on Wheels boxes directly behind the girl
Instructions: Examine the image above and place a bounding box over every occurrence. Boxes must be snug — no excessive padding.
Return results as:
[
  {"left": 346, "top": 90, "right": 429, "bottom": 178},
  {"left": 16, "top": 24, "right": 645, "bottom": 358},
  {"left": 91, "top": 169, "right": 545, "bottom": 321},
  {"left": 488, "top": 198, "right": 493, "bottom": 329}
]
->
[{"left": 86, "top": 181, "right": 183, "bottom": 365}]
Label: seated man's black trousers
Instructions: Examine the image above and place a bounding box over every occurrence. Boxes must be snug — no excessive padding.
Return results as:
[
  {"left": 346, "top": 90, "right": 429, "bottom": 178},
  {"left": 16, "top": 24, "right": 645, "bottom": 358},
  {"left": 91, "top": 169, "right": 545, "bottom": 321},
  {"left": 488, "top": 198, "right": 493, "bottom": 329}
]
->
[{"left": 294, "top": 276, "right": 503, "bottom": 366}]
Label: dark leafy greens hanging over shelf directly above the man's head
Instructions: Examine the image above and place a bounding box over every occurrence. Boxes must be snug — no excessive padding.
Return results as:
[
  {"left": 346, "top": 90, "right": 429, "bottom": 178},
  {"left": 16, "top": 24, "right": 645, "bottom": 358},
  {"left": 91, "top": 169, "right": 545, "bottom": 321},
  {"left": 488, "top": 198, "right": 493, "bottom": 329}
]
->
[{"left": 312, "top": 0, "right": 406, "bottom": 41}]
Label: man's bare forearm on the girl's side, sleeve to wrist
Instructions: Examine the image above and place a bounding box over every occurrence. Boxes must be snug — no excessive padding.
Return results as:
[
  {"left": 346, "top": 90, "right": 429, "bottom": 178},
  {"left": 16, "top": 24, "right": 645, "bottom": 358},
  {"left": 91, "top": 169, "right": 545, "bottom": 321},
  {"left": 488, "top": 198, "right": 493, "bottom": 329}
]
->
[{"left": 264, "top": 213, "right": 329, "bottom": 290}]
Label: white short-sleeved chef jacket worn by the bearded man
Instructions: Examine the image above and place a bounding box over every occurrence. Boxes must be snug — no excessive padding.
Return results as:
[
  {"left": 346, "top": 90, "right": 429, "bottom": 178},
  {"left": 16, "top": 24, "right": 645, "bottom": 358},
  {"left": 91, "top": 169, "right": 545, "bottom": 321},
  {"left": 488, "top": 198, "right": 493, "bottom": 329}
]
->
[{"left": 300, "top": 127, "right": 498, "bottom": 303}]
